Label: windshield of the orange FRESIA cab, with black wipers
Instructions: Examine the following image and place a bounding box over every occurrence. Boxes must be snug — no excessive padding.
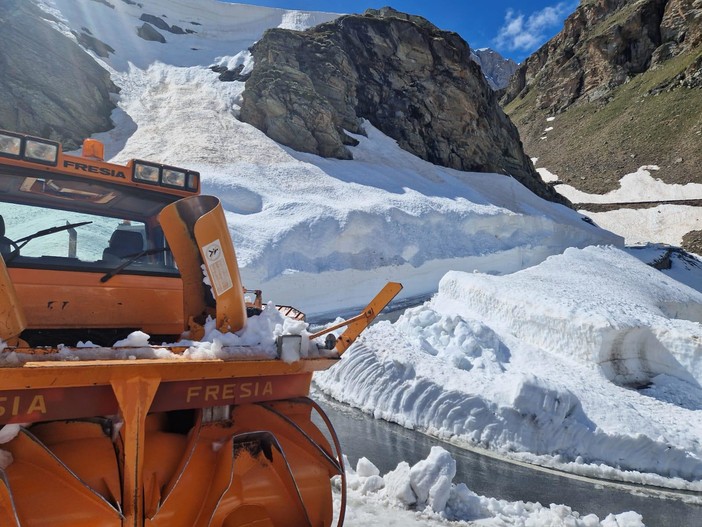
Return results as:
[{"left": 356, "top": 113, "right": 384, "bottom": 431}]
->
[{"left": 0, "top": 203, "right": 177, "bottom": 275}]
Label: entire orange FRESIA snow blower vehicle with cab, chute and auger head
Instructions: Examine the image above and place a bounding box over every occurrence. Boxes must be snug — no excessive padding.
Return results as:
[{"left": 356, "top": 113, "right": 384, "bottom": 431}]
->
[{"left": 0, "top": 131, "right": 401, "bottom": 527}]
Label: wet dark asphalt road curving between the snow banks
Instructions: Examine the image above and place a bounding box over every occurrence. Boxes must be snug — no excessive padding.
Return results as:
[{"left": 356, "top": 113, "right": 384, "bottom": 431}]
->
[{"left": 315, "top": 393, "right": 702, "bottom": 527}]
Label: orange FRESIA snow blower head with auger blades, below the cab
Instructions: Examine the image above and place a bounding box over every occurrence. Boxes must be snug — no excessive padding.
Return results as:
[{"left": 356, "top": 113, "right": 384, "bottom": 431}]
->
[{"left": 0, "top": 352, "right": 341, "bottom": 527}]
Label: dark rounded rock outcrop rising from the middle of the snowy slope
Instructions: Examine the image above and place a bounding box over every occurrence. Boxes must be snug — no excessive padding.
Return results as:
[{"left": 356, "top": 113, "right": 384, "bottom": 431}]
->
[{"left": 241, "top": 8, "right": 559, "bottom": 204}]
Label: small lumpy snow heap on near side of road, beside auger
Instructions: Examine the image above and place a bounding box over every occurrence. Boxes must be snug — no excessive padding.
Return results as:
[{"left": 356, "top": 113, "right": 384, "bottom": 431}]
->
[{"left": 337, "top": 447, "right": 643, "bottom": 527}]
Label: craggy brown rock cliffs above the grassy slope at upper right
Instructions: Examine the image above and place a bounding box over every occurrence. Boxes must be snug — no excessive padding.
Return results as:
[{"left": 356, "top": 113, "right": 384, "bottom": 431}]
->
[{"left": 502, "top": 0, "right": 702, "bottom": 113}]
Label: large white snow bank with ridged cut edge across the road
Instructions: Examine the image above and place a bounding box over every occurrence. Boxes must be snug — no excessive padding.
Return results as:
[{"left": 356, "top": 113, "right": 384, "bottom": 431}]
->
[{"left": 315, "top": 247, "right": 702, "bottom": 490}]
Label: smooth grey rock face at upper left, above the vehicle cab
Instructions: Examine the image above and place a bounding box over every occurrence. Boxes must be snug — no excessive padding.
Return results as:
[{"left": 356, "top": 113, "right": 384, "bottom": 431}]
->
[{"left": 0, "top": 0, "right": 118, "bottom": 149}]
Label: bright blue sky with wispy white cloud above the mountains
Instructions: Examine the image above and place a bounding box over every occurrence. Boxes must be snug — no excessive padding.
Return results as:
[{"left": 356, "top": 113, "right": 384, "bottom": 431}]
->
[{"left": 231, "top": 0, "right": 578, "bottom": 62}]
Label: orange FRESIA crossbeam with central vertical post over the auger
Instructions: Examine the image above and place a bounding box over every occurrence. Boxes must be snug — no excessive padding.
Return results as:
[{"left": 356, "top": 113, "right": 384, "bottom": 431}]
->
[{"left": 0, "top": 359, "right": 335, "bottom": 525}]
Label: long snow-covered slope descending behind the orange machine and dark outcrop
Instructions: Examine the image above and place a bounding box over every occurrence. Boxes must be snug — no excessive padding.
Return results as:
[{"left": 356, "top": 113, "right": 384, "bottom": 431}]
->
[{"left": 38, "top": 0, "right": 621, "bottom": 314}]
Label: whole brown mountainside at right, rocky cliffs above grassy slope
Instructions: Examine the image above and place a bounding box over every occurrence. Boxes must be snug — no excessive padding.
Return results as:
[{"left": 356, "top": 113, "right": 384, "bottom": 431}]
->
[{"left": 502, "top": 0, "right": 702, "bottom": 192}]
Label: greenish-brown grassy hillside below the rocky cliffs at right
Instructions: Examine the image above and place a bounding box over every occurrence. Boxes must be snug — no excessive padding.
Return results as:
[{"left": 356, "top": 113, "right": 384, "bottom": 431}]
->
[{"left": 505, "top": 48, "right": 702, "bottom": 198}]
